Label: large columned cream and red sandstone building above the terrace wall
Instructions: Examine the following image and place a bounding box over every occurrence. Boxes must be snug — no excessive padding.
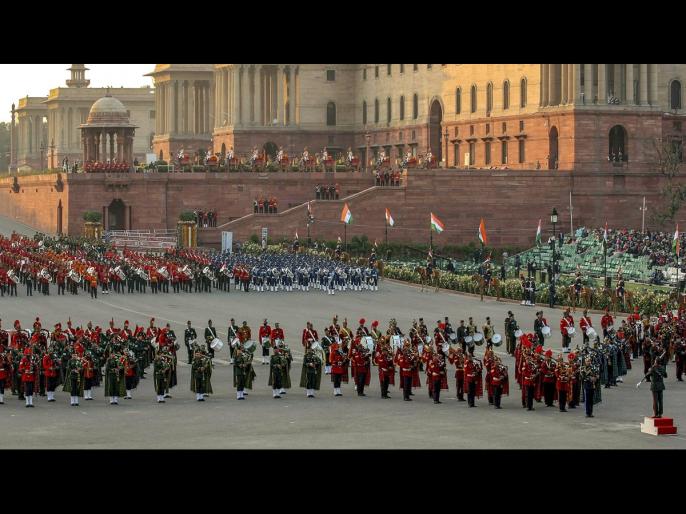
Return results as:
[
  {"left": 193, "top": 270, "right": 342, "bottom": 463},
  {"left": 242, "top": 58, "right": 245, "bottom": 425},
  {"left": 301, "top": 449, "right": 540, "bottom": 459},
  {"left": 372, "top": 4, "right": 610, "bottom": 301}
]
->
[{"left": 151, "top": 64, "right": 686, "bottom": 170}]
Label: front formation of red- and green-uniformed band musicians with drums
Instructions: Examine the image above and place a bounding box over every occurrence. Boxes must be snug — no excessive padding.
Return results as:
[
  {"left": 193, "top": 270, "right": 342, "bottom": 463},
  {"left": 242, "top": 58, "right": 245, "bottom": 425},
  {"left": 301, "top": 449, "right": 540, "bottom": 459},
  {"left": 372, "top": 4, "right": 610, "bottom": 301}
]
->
[{"left": 0, "top": 306, "right": 686, "bottom": 417}]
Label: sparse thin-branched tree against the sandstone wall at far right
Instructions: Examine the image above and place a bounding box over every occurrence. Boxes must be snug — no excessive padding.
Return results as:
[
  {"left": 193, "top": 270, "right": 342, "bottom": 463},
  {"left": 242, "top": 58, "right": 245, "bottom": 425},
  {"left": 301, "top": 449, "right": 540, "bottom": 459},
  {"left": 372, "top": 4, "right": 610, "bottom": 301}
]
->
[{"left": 652, "top": 138, "right": 686, "bottom": 225}]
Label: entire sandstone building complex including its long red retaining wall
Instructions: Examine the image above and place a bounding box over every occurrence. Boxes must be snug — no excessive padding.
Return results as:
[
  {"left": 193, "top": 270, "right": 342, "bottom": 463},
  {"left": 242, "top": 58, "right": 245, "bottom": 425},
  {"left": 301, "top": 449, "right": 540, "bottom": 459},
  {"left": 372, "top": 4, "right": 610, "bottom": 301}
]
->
[{"left": 0, "top": 64, "right": 686, "bottom": 245}]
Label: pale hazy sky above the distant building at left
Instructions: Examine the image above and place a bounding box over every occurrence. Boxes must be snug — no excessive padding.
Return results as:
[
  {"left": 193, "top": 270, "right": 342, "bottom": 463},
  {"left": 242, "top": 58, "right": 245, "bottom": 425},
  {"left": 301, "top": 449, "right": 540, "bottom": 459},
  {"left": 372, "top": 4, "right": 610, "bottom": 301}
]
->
[{"left": 0, "top": 64, "right": 155, "bottom": 121}]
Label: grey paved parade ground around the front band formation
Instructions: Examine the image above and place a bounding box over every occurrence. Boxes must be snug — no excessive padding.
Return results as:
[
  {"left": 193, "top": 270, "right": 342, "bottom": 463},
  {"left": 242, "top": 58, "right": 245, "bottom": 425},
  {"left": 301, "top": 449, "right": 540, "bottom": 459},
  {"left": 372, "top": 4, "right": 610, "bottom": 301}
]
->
[{"left": 0, "top": 274, "right": 686, "bottom": 449}]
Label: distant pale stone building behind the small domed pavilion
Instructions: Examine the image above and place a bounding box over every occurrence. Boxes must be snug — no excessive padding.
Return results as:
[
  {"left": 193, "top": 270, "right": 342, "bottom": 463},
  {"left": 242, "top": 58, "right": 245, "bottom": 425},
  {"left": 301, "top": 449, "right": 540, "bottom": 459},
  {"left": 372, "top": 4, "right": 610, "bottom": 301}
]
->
[{"left": 15, "top": 64, "right": 156, "bottom": 170}]
